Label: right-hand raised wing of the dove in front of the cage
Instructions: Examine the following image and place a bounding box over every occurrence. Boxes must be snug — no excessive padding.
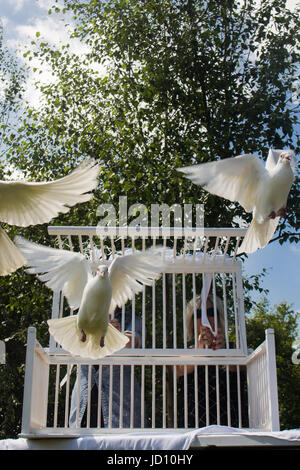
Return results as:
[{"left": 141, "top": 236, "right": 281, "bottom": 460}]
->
[{"left": 108, "top": 251, "right": 161, "bottom": 313}]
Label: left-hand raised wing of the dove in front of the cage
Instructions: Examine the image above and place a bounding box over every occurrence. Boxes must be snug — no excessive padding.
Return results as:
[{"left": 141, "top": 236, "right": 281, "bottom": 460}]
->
[{"left": 14, "top": 237, "right": 92, "bottom": 309}]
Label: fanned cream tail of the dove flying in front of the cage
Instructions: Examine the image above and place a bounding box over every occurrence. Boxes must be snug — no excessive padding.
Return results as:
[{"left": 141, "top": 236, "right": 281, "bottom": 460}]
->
[{"left": 47, "top": 315, "right": 128, "bottom": 359}]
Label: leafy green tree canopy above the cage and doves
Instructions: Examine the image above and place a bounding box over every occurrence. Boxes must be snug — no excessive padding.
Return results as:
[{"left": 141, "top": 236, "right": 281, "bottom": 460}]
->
[{"left": 4, "top": 0, "right": 299, "bottom": 235}]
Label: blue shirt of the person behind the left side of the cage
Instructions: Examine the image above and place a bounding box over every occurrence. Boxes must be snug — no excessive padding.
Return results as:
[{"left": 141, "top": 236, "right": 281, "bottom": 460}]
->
[{"left": 69, "top": 311, "right": 142, "bottom": 428}]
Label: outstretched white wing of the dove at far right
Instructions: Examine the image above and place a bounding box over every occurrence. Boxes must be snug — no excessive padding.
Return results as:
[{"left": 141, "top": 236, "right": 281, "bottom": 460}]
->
[{"left": 177, "top": 154, "right": 269, "bottom": 212}]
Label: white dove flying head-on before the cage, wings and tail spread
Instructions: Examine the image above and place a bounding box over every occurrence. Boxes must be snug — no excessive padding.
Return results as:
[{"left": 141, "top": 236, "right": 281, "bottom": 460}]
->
[{"left": 15, "top": 237, "right": 161, "bottom": 359}]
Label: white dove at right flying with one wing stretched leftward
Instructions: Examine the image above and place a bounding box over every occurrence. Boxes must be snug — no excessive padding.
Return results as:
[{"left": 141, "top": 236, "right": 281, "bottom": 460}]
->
[{"left": 177, "top": 149, "right": 296, "bottom": 253}]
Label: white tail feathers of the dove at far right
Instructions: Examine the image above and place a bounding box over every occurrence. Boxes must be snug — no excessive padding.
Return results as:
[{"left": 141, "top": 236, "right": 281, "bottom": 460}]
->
[{"left": 238, "top": 217, "right": 279, "bottom": 253}]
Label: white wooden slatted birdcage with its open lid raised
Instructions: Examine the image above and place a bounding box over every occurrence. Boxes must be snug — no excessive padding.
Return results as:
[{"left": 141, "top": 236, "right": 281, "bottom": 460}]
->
[{"left": 22, "top": 227, "right": 279, "bottom": 437}]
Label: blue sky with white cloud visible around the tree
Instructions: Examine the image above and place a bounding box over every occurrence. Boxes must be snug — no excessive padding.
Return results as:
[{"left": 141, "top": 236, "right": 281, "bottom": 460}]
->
[{"left": 0, "top": 0, "right": 300, "bottom": 326}]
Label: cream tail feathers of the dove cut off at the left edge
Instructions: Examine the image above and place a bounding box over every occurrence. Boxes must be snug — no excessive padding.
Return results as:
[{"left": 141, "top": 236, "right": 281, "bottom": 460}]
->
[{"left": 0, "top": 228, "right": 26, "bottom": 276}]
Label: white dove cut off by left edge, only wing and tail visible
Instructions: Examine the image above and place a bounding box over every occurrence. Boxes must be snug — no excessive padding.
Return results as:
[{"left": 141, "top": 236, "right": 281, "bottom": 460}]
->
[{"left": 0, "top": 160, "right": 99, "bottom": 276}]
